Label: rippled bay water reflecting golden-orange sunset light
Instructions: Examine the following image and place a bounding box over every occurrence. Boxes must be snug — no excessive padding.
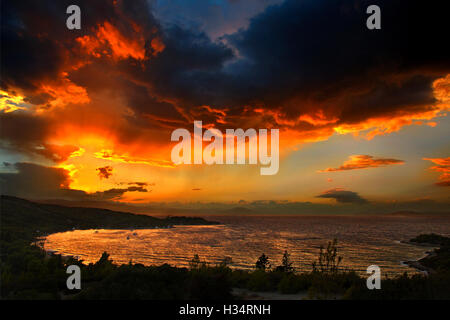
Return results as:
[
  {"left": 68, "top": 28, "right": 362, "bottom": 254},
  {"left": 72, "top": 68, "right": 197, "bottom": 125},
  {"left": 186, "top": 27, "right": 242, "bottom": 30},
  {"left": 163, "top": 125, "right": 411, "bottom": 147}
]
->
[{"left": 44, "top": 216, "right": 450, "bottom": 274}]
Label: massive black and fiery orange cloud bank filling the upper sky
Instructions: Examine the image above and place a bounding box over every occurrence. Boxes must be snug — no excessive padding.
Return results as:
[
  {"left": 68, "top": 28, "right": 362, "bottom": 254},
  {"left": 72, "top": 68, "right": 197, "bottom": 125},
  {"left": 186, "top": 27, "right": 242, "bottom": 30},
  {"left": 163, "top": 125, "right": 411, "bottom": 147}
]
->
[{"left": 0, "top": 0, "right": 450, "bottom": 201}]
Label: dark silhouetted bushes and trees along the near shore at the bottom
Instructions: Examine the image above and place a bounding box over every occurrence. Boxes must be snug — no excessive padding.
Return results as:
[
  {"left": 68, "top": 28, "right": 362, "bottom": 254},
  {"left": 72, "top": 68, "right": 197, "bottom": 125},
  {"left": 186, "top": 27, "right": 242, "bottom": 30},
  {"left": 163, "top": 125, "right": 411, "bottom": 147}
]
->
[{"left": 1, "top": 244, "right": 450, "bottom": 300}]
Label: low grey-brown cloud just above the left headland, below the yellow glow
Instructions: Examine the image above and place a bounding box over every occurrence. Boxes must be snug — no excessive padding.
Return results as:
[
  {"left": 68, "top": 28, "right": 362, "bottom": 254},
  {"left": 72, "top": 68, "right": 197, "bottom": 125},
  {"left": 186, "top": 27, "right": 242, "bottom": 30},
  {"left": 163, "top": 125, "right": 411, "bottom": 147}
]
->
[{"left": 0, "top": 162, "right": 149, "bottom": 201}]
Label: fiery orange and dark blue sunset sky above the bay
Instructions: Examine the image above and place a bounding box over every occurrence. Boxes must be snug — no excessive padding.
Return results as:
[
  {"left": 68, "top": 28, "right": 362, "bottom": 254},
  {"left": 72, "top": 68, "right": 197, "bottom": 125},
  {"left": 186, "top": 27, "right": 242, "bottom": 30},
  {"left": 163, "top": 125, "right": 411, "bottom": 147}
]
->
[{"left": 0, "top": 0, "right": 450, "bottom": 214}]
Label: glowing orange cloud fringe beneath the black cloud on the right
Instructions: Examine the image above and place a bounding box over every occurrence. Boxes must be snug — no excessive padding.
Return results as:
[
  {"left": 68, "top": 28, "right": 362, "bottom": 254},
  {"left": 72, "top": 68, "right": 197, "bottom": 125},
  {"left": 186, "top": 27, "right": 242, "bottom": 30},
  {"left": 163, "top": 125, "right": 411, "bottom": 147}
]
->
[{"left": 239, "top": 75, "right": 450, "bottom": 146}]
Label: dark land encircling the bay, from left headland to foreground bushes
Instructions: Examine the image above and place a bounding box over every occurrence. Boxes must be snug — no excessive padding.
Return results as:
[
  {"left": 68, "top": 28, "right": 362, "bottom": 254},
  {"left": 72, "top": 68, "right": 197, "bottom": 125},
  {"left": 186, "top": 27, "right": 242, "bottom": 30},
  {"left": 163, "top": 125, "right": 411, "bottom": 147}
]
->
[{"left": 0, "top": 196, "right": 450, "bottom": 301}]
